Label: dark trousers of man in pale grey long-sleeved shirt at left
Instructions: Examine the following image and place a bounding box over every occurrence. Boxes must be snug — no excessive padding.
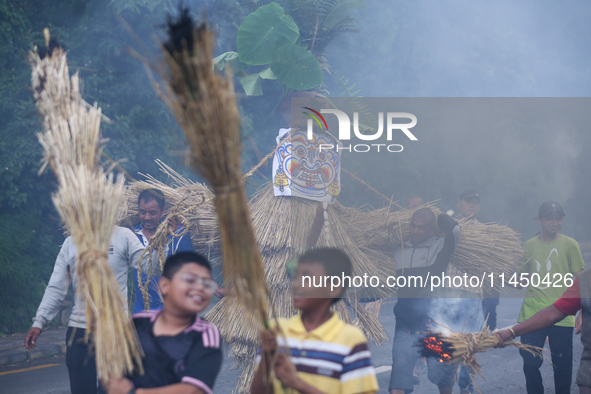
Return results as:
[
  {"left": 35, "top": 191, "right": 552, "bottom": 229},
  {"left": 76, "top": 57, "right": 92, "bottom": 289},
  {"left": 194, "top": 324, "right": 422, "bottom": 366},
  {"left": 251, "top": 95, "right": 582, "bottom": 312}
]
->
[{"left": 66, "top": 327, "right": 101, "bottom": 394}]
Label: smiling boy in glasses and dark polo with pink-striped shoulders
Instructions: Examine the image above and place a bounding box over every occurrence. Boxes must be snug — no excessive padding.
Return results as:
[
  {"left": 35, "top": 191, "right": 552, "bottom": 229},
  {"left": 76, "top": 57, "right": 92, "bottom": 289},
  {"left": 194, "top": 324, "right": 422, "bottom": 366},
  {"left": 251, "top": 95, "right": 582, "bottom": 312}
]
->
[{"left": 108, "top": 252, "right": 222, "bottom": 394}]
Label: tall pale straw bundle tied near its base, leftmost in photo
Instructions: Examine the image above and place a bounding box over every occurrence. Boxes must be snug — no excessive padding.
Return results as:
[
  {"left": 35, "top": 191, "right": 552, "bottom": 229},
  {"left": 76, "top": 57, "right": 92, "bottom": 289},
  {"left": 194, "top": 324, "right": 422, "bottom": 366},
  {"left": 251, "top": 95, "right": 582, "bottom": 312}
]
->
[{"left": 29, "top": 29, "right": 143, "bottom": 384}]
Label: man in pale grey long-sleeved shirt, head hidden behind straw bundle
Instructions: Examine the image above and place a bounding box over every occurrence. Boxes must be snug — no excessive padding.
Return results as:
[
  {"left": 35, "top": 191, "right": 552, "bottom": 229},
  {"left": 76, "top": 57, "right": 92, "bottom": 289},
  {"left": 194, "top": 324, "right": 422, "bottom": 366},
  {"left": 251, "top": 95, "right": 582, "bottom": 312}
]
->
[{"left": 25, "top": 226, "right": 159, "bottom": 394}]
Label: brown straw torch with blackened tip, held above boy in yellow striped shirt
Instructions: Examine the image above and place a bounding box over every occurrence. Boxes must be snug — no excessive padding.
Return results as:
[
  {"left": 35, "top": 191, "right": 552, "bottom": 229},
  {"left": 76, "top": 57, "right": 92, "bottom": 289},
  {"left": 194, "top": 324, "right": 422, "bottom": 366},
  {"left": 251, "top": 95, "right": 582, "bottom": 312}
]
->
[{"left": 154, "top": 9, "right": 267, "bottom": 330}]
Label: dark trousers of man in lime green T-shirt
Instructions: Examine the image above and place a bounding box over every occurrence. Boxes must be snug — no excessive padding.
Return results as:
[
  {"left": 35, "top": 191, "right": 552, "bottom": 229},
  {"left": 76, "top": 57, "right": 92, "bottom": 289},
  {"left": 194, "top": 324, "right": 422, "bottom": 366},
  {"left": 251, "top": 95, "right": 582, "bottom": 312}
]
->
[{"left": 519, "top": 326, "right": 573, "bottom": 394}]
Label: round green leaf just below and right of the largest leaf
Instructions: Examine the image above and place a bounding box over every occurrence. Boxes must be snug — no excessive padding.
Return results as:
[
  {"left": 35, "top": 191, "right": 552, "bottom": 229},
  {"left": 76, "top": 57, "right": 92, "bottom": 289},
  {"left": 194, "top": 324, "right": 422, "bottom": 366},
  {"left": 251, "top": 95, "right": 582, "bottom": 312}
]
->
[{"left": 271, "top": 44, "right": 322, "bottom": 90}]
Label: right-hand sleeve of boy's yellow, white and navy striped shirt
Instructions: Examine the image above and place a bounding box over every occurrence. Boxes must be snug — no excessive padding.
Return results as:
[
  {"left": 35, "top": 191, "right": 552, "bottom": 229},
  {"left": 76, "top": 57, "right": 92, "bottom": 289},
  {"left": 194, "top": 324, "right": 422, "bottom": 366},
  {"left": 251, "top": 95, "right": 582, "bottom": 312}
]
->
[{"left": 341, "top": 341, "right": 378, "bottom": 394}]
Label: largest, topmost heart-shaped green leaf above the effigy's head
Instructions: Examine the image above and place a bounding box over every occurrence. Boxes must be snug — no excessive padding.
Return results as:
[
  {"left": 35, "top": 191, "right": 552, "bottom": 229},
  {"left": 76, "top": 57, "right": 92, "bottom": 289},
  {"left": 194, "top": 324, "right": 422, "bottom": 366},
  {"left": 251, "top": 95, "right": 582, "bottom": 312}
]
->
[{"left": 236, "top": 2, "right": 300, "bottom": 65}]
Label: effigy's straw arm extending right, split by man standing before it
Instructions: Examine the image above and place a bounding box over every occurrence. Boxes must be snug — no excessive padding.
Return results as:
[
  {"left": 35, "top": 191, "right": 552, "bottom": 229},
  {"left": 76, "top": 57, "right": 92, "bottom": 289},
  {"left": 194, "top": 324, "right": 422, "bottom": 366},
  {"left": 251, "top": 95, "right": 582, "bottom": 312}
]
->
[{"left": 343, "top": 202, "right": 522, "bottom": 286}]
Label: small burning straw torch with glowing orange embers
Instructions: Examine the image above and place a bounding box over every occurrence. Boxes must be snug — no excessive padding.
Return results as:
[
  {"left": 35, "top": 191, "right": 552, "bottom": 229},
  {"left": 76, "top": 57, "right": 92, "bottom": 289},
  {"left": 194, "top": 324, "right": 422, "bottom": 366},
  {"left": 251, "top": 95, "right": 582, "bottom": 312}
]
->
[{"left": 419, "top": 326, "right": 543, "bottom": 377}]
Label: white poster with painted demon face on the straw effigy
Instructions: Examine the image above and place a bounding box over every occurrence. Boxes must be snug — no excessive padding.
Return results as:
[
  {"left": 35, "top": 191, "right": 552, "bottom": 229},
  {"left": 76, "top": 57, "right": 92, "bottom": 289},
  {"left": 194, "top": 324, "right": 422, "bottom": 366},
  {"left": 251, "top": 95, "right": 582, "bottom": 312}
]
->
[{"left": 273, "top": 129, "right": 341, "bottom": 204}]
